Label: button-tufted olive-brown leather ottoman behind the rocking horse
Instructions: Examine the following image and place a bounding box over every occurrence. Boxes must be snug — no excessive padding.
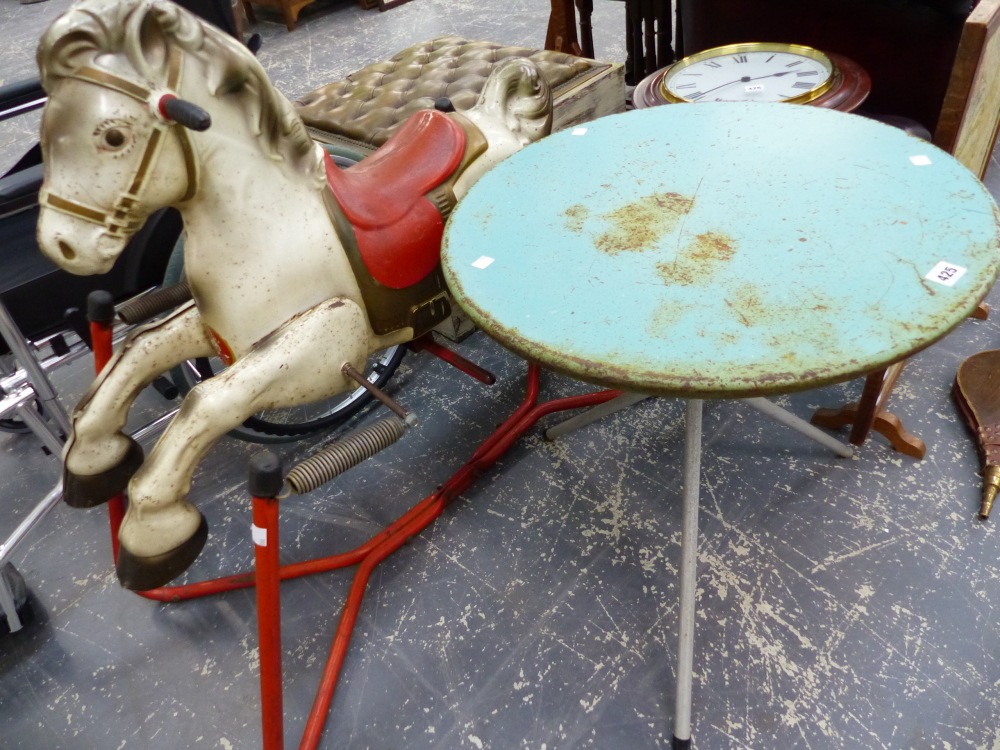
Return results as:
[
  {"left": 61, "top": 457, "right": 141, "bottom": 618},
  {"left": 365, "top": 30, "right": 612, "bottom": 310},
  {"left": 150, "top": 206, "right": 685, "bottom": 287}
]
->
[{"left": 295, "top": 36, "right": 625, "bottom": 155}]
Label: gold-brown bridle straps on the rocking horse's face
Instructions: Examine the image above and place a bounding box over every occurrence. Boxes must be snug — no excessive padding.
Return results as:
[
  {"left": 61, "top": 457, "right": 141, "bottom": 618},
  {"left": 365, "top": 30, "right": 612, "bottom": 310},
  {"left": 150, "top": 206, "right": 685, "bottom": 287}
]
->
[{"left": 38, "top": 47, "right": 198, "bottom": 239}]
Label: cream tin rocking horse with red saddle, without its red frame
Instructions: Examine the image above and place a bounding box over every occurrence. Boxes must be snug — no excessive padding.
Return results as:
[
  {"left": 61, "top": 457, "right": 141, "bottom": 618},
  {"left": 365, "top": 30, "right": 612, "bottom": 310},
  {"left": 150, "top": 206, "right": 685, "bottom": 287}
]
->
[{"left": 38, "top": 0, "right": 551, "bottom": 590}]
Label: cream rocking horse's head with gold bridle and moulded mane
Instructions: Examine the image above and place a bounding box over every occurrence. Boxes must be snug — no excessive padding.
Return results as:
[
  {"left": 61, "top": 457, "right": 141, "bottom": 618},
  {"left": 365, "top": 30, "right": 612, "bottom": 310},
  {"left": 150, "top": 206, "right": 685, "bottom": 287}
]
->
[{"left": 38, "top": 0, "right": 315, "bottom": 274}]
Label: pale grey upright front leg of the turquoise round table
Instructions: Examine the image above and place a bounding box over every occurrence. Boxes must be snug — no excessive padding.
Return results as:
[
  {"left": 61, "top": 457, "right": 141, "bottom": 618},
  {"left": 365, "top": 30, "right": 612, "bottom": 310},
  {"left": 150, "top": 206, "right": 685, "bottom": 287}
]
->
[{"left": 673, "top": 399, "right": 702, "bottom": 750}]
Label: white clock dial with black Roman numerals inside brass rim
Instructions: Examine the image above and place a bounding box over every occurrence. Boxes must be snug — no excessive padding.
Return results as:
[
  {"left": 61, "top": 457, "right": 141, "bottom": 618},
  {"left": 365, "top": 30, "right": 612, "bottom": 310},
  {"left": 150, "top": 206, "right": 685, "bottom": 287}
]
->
[{"left": 662, "top": 50, "right": 834, "bottom": 102}]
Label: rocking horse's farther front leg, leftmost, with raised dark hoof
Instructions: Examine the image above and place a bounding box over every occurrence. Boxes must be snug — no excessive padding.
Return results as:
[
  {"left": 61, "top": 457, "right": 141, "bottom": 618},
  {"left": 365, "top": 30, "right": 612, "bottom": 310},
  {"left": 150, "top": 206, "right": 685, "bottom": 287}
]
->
[{"left": 63, "top": 302, "right": 215, "bottom": 508}]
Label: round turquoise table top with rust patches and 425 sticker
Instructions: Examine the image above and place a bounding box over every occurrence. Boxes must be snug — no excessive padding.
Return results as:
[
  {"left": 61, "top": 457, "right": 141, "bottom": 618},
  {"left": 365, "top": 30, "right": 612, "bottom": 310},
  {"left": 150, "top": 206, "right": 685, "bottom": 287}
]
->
[{"left": 442, "top": 102, "right": 1000, "bottom": 406}]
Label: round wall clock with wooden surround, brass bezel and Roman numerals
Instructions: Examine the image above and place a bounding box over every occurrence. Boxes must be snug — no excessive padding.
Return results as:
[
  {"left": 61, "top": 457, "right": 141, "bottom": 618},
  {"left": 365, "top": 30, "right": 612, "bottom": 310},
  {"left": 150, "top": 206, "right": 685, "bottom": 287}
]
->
[{"left": 632, "top": 42, "right": 871, "bottom": 112}]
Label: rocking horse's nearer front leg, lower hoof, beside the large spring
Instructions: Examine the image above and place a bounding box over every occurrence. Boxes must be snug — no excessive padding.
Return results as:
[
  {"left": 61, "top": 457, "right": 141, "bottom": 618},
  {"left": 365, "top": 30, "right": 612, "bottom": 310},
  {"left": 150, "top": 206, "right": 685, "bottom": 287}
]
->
[{"left": 117, "top": 298, "right": 371, "bottom": 591}]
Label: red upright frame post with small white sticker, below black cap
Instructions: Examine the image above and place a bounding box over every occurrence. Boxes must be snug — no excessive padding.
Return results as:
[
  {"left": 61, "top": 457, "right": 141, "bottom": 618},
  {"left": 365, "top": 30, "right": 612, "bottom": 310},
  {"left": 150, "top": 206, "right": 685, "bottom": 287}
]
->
[{"left": 253, "top": 497, "right": 285, "bottom": 750}]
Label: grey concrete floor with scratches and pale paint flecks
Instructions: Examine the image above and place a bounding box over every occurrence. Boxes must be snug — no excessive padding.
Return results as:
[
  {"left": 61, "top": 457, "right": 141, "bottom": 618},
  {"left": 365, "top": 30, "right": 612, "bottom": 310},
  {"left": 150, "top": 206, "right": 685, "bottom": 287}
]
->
[{"left": 0, "top": 0, "right": 1000, "bottom": 750}]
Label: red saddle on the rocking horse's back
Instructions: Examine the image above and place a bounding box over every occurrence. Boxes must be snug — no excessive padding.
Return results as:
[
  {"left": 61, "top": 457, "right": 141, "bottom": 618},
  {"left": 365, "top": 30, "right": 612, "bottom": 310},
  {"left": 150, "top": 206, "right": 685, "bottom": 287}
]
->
[{"left": 326, "top": 110, "right": 465, "bottom": 289}]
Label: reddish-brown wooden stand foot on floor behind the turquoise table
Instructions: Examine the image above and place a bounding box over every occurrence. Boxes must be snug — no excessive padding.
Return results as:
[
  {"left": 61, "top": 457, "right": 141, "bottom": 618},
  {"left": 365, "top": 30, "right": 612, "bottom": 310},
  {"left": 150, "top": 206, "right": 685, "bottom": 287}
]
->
[{"left": 810, "top": 361, "right": 927, "bottom": 460}]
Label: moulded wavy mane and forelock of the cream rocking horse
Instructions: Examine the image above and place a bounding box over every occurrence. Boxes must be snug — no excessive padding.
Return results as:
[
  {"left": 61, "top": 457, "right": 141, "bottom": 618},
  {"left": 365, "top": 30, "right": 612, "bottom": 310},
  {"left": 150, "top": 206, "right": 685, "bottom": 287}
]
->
[{"left": 37, "top": 0, "right": 322, "bottom": 176}]
